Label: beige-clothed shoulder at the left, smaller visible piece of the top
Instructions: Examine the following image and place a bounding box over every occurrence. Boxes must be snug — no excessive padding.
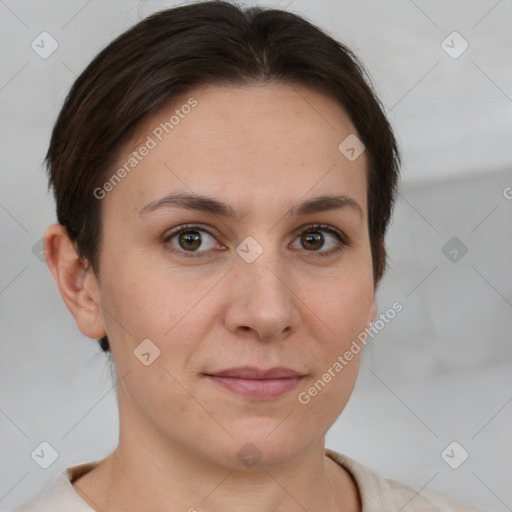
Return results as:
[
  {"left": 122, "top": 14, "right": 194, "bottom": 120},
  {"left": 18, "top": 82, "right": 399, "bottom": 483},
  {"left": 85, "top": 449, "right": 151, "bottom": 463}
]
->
[{"left": 12, "top": 460, "right": 100, "bottom": 512}]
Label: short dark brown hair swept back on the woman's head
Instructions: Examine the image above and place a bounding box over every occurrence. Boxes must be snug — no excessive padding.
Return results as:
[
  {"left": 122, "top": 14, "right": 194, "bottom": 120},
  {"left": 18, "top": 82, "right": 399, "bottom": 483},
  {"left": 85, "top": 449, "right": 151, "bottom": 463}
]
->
[{"left": 45, "top": 1, "right": 400, "bottom": 351}]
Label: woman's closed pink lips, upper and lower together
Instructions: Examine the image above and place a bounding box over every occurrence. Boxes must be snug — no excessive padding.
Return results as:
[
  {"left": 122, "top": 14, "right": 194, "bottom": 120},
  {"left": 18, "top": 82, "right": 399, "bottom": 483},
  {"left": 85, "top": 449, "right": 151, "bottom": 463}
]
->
[{"left": 206, "top": 366, "right": 304, "bottom": 400}]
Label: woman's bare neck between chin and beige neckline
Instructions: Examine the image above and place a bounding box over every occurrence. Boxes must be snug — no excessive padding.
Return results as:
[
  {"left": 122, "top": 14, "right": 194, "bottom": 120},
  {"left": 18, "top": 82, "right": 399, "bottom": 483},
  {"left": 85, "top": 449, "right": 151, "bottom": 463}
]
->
[{"left": 73, "top": 428, "right": 361, "bottom": 512}]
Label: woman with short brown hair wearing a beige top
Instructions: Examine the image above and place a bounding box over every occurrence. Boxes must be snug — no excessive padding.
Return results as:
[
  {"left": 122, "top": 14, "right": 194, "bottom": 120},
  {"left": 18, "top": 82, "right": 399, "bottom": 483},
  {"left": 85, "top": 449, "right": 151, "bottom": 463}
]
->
[{"left": 18, "top": 2, "right": 486, "bottom": 512}]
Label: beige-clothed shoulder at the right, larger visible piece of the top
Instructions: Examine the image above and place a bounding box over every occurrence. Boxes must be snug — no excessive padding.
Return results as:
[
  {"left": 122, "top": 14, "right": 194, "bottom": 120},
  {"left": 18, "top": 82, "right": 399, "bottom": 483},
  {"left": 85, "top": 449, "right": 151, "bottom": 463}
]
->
[{"left": 325, "top": 449, "right": 484, "bottom": 512}]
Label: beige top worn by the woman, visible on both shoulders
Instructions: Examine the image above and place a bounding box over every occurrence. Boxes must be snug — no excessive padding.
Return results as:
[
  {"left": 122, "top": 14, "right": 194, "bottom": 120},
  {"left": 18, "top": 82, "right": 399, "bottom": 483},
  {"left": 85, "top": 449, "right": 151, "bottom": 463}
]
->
[{"left": 13, "top": 448, "right": 483, "bottom": 512}]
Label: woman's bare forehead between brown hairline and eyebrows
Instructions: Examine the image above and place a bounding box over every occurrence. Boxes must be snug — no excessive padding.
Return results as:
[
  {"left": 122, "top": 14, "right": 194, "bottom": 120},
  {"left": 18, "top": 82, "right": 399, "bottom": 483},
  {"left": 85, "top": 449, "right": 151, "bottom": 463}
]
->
[{"left": 105, "top": 83, "right": 366, "bottom": 219}]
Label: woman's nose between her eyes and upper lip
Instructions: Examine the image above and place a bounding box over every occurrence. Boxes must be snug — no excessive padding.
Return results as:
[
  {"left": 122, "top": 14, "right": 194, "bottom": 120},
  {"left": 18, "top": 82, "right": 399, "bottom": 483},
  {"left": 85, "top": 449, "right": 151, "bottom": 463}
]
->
[{"left": 225, "top": 242, "right": 302, "bottom": 340}]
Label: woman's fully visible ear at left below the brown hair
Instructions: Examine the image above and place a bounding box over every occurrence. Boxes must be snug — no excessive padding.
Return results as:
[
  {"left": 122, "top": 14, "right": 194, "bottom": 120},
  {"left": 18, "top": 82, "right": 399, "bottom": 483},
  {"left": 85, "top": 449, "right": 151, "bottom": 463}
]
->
[{"left": 44, "top": 224, "right": 106, "bottom": 338}]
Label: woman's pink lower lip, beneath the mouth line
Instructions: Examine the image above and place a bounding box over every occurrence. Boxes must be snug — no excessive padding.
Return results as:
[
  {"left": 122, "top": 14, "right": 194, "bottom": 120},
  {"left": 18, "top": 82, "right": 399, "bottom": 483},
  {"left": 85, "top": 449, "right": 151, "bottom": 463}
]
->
[{"left": 207, "top": 375, "right": 302, "bottom": 400}]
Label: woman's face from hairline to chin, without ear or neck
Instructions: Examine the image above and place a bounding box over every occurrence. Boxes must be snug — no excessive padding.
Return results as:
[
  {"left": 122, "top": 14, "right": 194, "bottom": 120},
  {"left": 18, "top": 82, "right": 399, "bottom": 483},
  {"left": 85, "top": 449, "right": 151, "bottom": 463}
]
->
[{"left": 87, "top": 84, "right": 376, "bottom": 467}]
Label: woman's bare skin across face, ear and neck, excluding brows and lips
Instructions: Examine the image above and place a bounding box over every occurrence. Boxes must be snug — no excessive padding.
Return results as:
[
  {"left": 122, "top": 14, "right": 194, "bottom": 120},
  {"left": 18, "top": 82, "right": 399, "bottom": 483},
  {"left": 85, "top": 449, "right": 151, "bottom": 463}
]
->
[{"left": 45, "top": 83, "right": 377, "bottom": 512}]
